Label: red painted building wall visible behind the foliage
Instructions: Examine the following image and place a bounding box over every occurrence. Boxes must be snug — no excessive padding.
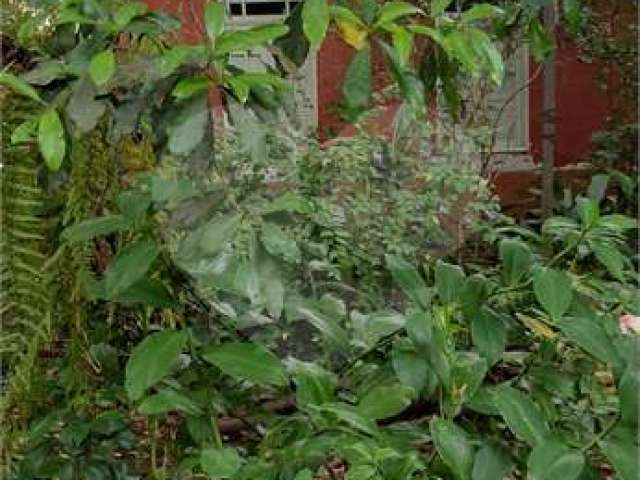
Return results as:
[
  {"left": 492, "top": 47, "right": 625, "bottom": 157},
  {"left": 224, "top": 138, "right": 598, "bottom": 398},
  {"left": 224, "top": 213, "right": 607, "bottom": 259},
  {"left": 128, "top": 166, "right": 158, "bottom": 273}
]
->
[{"left": 146, "top": 0, "right": 632, "bottom": 206}]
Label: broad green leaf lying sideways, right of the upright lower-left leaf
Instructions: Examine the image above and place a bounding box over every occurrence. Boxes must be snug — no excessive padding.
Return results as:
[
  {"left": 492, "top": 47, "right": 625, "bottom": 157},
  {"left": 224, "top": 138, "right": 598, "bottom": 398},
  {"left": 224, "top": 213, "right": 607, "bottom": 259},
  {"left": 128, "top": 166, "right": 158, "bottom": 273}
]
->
[{"left": 202, "top": 342, "right": 287, "bottom": 386}]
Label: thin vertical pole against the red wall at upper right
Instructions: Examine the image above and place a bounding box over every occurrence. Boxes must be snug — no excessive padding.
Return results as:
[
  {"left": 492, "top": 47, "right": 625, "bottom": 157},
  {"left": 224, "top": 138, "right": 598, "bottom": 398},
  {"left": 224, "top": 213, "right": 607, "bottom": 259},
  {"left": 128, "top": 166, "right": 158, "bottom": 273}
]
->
[{"left": 542, "top": 1, "right": 556, "bottom": 218}]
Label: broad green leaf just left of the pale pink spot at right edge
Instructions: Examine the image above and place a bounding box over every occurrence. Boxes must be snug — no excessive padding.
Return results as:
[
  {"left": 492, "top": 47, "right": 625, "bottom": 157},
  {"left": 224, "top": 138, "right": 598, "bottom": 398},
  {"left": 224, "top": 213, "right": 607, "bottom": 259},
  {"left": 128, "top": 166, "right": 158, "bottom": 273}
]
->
[{"left": 558, "top": 315, "right": 620, "bottom": 366}]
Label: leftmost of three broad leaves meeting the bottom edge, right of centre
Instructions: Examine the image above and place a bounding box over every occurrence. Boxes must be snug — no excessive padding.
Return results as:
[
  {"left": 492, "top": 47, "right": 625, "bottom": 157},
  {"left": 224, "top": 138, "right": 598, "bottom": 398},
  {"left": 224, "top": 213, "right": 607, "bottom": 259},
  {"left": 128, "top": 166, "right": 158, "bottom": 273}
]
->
[{"left": 429, "top": 418, "right": 474, "bottom": 480}]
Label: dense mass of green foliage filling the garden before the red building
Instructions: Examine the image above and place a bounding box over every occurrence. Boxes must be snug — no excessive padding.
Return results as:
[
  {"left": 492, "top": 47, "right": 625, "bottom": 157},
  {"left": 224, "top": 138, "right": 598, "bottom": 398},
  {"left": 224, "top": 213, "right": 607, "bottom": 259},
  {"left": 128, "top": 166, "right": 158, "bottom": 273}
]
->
[{"left": 0, "top": 0, "right": 640, "bottom": 480}]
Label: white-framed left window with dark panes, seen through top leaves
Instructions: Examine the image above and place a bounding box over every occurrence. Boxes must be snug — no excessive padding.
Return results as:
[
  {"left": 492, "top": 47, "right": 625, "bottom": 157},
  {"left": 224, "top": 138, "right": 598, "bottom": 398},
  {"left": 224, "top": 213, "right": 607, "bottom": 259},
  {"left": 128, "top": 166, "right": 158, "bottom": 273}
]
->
[{"left": 226, "top": 0, "right": 318, "bottom": 130}]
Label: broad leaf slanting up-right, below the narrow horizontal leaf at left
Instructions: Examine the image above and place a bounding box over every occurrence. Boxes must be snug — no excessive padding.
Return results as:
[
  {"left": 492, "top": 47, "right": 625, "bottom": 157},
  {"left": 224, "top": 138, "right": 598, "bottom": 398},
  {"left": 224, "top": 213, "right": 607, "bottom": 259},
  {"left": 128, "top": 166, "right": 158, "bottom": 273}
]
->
[{"left": 105, "top": 241, "right": 160, "bottom": 297}]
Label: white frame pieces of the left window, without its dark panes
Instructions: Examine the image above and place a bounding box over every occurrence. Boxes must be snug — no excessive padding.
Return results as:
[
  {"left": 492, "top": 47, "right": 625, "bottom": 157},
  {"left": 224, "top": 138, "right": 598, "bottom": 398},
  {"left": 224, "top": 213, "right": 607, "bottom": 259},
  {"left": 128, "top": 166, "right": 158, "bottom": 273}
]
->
[{"left": 225, "top": 0, "right": 318, "bottom": 130}]
